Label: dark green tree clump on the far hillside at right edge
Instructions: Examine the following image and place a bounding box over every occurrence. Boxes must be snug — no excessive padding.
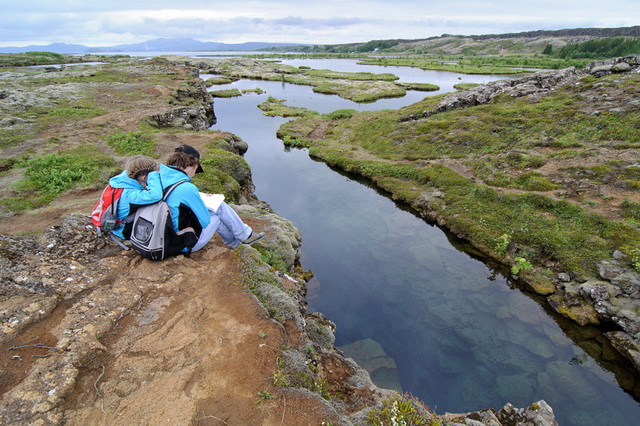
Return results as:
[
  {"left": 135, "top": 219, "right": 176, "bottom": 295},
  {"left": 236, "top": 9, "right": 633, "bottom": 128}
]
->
[{"left": 542, "top": 37, "right": 640, "bottom": 59}]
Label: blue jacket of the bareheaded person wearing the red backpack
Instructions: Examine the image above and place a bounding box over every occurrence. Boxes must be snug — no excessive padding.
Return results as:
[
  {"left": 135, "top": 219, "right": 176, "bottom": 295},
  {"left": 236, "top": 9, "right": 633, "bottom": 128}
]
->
[{"left": 109, "top": 170, "right": 162, "bottom": 238}]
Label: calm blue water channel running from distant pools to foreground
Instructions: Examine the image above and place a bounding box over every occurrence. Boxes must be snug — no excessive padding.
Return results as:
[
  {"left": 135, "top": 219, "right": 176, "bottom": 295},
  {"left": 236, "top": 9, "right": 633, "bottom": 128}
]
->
[{"left": 203, "top": 60, "right": 640, "bottom": 425}]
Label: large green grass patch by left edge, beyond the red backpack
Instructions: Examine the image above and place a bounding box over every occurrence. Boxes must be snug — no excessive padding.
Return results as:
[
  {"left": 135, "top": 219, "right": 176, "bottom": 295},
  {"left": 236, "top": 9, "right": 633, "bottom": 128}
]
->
[{"left": 0, "top": 145, "right": 116, "bottom": 211}]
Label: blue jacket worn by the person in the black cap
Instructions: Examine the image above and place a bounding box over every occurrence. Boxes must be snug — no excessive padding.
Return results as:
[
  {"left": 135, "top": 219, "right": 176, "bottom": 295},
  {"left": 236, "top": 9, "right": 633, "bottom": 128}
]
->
[{"left": 160, "top": 164, "right": 211, "bottom": 236}]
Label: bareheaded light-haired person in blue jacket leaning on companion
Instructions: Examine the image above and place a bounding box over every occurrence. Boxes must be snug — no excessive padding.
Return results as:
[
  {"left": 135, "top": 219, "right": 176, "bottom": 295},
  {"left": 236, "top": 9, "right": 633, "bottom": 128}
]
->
[{"left": 109, "top": 155, "right": 162, "bottom": 239}]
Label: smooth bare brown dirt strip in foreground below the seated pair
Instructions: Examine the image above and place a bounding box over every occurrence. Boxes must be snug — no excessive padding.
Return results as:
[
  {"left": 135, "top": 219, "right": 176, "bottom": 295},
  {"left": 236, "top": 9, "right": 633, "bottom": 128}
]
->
[{"left": 60, "top": 243, "right": 342, "bottom": 425}]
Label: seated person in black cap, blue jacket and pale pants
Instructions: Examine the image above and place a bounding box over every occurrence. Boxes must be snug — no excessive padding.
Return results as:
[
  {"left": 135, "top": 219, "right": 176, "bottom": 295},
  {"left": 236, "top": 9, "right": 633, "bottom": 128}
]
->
[{"left": 160, "top": 152, "right": 264, "bottom": 252}]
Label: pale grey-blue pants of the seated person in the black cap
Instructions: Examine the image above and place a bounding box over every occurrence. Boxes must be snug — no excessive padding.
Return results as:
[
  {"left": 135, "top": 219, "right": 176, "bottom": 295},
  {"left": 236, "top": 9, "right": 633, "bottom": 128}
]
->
[{"left": 191, "top": 202, "right": 252, "bottom": 252}]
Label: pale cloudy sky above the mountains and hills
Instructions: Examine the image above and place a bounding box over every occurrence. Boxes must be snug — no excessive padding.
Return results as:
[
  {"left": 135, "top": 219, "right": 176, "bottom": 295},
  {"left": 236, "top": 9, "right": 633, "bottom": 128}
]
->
[{"left": 0, "top": 0, "right": 640, "bottom": 47}]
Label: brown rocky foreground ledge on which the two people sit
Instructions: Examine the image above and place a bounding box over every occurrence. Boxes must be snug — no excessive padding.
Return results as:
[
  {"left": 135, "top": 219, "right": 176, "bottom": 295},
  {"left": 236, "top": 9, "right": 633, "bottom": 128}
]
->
[{"left": 0, "top": 211, "right": 556, "bottom": 425}]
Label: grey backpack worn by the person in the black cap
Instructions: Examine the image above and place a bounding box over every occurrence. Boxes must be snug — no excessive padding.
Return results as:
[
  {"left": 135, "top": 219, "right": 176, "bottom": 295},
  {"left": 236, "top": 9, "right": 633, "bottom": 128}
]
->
[{"left": 124, "top": 180, "right": 198, "bottom": 260}]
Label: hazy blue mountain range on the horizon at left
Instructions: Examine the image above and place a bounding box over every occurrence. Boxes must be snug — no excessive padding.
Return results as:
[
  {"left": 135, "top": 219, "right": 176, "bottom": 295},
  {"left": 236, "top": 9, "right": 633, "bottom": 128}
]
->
[{"left": 0, "top": 38, "right": 300, "bottom": 54}]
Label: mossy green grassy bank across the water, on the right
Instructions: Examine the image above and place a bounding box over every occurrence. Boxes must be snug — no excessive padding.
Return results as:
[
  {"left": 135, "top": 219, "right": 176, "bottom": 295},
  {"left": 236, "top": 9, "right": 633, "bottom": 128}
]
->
[{"left": 279, "top": 70, "right": 640, "bottom": 282}]
